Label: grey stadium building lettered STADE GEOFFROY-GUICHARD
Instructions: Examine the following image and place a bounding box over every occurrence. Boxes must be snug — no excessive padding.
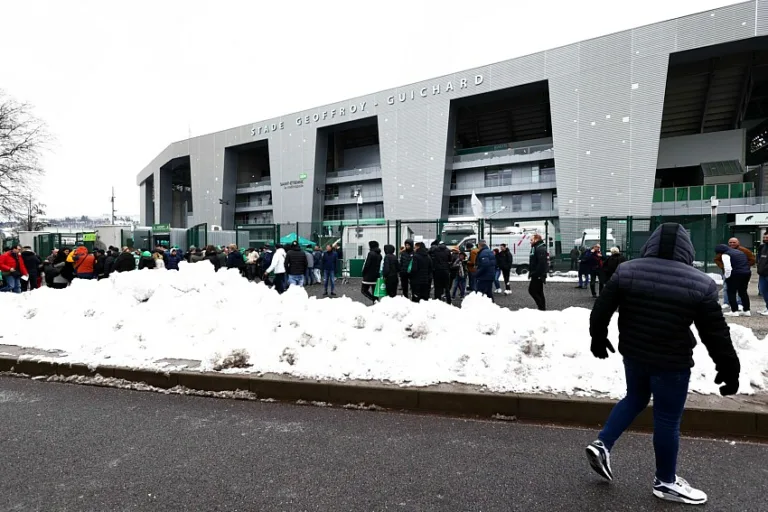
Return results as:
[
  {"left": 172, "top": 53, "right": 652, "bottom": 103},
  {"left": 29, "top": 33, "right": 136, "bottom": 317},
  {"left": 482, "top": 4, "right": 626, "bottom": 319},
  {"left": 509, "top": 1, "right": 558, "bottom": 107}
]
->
[{"left": 137, "top": 0, "right": 768, "bottom": 248}]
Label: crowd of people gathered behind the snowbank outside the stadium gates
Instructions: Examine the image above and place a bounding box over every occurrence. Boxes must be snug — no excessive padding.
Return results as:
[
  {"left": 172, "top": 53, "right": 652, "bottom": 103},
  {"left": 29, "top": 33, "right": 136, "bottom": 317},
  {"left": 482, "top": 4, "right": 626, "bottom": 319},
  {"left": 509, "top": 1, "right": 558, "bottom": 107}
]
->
[{"left": 0, "top": 232, "right": 768, "bottom": 316}]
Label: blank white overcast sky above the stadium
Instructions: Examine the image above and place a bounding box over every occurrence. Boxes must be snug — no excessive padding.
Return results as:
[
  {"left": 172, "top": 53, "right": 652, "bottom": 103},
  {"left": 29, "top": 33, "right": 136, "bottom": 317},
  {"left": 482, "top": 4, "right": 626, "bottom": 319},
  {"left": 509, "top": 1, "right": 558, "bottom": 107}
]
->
[{"left": 0, "top": 0, "right": 738, "bottom": 216}]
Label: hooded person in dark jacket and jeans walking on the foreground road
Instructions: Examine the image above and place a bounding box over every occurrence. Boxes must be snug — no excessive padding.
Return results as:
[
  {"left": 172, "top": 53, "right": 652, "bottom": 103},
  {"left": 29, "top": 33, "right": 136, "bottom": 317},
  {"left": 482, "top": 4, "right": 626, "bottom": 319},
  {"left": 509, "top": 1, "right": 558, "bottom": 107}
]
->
[{"left": 587, "top": 223, "right": 740, "bottom": 504}]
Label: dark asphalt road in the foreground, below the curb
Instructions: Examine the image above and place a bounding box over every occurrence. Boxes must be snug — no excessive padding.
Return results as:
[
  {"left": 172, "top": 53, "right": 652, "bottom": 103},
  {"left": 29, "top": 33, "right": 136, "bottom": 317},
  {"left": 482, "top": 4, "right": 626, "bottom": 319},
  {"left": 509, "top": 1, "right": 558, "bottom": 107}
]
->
[{"left": 0, "top": 377, "right": 768, "bottom": 512}]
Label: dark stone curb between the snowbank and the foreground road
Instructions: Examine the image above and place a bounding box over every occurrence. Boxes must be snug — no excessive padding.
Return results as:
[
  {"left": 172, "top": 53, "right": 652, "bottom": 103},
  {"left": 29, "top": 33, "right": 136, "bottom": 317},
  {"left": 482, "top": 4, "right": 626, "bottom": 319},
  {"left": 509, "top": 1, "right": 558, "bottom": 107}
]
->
[{"left": 0, "top": 356, "right": 768, "bottom": 439}]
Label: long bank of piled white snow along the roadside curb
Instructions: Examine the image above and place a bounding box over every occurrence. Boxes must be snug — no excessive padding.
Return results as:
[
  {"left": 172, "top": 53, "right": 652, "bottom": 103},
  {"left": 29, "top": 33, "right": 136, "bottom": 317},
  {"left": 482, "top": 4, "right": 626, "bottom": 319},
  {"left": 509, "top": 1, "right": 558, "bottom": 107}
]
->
[{"left": 0, "top": 264, "right": 768, "bottom": 397}]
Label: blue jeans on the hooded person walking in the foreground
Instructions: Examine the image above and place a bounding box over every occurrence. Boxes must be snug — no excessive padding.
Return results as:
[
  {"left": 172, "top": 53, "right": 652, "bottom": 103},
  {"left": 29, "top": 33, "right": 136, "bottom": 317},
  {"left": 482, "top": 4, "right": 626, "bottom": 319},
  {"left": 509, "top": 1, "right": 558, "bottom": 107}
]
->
[{"left": 598, "top": 358, "right": 691, "bottom": 483}]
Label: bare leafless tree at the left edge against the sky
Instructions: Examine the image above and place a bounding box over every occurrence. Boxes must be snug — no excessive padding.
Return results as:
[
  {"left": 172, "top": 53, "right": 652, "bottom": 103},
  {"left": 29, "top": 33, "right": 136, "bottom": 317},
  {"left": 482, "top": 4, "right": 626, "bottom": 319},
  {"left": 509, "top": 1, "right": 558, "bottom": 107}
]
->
[{"left": 0, "top": 90, "right": 50, "bottom": 218}]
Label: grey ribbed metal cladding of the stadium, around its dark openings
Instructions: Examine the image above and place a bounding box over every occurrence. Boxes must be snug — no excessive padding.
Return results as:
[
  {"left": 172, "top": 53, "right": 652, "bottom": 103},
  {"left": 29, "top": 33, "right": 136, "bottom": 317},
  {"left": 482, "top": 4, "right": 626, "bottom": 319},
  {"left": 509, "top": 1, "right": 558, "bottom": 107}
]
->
[{"left": 137, "top": 1, "right": 768, "bottom": 227}]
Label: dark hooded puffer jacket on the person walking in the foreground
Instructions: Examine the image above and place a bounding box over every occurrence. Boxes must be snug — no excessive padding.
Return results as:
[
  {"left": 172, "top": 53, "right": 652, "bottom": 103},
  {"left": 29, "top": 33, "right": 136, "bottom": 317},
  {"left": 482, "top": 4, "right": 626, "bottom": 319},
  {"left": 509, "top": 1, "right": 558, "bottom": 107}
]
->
[{"left": 589, "top": 223, "right": 739, "bottom": 373}]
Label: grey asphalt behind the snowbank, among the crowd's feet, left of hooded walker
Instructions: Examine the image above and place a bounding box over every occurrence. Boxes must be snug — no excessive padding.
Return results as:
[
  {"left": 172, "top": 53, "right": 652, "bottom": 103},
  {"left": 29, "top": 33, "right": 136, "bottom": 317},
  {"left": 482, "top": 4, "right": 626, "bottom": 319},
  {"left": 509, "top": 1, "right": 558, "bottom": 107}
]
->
[{"left": 306, "top": 279, "right": 594, "bottom": 310}]
